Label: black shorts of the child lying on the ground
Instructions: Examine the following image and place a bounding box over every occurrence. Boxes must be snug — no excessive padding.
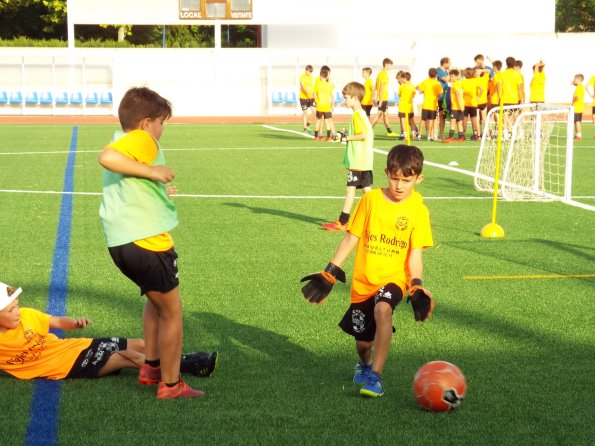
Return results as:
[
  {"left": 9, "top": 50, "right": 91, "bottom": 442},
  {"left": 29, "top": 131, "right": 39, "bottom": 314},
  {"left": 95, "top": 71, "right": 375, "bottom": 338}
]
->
[{"left": 66, "top": 338, "right": 128, "bottom": 378}]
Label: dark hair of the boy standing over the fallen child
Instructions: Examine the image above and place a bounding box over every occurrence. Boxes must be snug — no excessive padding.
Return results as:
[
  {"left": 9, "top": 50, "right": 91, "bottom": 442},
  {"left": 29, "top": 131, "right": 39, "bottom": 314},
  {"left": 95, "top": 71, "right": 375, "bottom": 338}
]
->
[{"left": 118, "top": 87, "right": 172, "bottom": 131}]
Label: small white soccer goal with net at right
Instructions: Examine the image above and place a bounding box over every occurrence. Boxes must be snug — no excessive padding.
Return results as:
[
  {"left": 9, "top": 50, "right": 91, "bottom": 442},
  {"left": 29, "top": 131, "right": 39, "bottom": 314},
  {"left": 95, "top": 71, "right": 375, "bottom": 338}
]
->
[{"left": 474, "top": 104, "right": 573, "bottom": 201}]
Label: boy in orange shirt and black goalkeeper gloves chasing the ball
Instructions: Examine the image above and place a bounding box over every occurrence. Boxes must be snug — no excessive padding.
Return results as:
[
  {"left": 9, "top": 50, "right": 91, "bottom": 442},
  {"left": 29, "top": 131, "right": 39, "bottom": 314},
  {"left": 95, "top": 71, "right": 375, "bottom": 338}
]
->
[{"left": 302, "top": 145, "right": 434, "bottom": 397}]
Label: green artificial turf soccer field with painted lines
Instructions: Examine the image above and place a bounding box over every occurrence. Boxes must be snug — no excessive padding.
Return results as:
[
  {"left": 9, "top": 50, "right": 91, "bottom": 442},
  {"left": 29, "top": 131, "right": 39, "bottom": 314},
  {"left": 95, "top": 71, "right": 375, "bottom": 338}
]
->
[{"left": 0, "top": 123, "right": 595, "bottom": 445}]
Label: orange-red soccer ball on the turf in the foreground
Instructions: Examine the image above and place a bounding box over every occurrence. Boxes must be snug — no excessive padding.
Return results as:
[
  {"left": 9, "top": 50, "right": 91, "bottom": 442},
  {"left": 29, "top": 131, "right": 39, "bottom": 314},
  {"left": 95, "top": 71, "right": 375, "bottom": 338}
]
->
[{"left": 413, "top": 361, "right": 467, "bottom": 412}]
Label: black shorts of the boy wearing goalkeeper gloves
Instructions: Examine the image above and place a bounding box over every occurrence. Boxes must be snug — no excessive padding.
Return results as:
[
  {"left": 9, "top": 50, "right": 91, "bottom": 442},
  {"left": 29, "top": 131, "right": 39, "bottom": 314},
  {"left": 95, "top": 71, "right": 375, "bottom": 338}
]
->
[{"left": 339, "top": 283, "right": 403, "bottom": 342}]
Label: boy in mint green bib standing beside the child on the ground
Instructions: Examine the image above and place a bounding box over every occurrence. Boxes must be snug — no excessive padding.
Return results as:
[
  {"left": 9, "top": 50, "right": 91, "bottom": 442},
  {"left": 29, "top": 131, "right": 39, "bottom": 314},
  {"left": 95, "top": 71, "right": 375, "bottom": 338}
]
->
[{"left": 99, "top": 87, "right": 204, "bottom": 399}]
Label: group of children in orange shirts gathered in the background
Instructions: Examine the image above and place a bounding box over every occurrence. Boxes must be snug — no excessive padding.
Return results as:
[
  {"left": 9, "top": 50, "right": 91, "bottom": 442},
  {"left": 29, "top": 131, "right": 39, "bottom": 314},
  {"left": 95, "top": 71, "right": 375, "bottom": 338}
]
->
[{"left": 300, "top": 54, "right": 595, "bottom": 143}]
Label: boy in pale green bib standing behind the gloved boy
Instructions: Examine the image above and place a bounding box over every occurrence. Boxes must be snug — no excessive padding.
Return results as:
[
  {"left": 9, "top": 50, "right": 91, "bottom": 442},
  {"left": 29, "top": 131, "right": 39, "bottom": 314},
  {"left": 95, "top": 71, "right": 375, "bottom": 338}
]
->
[{"left": 322, "top": 82, "right": 374, "bottom": 231}]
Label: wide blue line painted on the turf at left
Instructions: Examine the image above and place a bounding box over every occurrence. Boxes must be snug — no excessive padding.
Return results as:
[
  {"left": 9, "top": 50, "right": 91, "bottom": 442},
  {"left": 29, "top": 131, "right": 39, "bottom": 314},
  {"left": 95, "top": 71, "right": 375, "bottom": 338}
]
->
[{"left": 25, "top": 126, "right": 78, "bottom": 446}]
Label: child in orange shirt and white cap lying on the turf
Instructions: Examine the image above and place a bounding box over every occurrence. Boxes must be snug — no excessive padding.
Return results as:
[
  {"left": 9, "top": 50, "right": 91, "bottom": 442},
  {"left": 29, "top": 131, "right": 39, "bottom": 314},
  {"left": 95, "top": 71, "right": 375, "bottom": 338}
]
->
[{"left": 0, "top": 283, "right": 217, "bottom": 379}]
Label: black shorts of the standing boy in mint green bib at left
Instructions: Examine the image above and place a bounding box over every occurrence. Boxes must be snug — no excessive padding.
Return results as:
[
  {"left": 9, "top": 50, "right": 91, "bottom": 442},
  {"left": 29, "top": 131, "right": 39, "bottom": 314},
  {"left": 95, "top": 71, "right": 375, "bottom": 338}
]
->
[{"left": 108, "top": 243, "right": 180, "bottom": 296}]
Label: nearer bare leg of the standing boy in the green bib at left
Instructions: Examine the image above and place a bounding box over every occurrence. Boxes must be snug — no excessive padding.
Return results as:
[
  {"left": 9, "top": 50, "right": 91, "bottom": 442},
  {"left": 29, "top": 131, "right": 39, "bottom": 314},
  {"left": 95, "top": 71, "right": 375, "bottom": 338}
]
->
[{"left": 145, "top": 287, "right": 183, "bottom": 383}]
